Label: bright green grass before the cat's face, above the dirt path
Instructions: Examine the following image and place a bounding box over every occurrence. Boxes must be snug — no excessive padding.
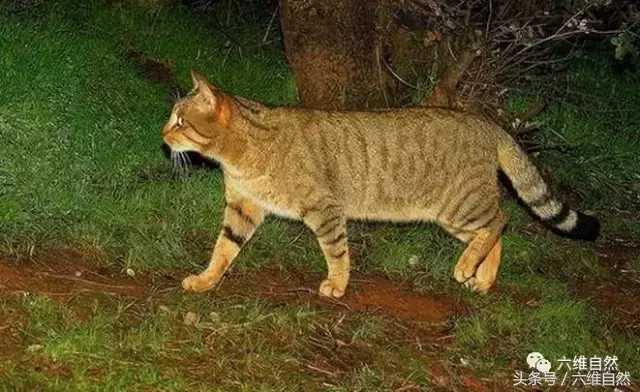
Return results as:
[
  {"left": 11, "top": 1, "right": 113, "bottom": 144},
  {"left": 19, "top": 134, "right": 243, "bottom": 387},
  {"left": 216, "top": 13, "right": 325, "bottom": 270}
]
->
[{"left": 0, "top": 0, "right": 294, "bottom": 269}]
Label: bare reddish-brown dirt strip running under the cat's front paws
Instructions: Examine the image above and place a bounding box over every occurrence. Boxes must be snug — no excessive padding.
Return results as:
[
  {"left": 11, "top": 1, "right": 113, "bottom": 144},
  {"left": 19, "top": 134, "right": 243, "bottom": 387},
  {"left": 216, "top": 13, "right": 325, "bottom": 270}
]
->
[{"left": 0, "top": 248, "right": 466, "bottom": 325}]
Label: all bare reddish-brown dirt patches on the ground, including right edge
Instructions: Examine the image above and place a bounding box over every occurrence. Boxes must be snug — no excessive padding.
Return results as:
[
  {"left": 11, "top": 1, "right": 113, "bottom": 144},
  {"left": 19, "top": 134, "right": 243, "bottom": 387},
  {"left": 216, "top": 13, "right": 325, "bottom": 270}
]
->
[{"left": 0, "top": 241, "right": 640, "bottom": 391}]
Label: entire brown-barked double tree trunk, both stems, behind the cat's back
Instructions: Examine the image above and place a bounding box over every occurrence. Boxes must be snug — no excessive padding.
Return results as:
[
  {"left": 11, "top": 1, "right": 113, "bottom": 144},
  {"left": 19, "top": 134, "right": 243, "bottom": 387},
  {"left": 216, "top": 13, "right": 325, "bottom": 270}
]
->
[{"left": 280, "top": 0, "right": 476, "bottom": 109}]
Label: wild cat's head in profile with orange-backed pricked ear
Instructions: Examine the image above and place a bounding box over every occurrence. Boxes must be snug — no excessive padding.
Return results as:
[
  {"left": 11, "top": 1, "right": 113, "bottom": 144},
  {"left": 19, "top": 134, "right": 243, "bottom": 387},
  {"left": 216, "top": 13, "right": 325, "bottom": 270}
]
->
[{"left": 162, "top": 71, "right": 232, "bottom": 157}]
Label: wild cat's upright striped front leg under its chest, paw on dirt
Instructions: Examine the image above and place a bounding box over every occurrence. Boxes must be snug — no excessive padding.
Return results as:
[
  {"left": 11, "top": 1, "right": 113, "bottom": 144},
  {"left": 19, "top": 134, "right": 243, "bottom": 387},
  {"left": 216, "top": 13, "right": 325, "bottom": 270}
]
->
[{"left": 301, "top": 199, "right": 351, "bottom": 298}]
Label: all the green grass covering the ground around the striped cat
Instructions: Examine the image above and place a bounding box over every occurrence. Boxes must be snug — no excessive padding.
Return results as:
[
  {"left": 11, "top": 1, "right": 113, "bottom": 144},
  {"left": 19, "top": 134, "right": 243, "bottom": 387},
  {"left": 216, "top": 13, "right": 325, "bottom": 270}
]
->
[{"left": 0, "top": 2, "right": 640, "bottom": 391}]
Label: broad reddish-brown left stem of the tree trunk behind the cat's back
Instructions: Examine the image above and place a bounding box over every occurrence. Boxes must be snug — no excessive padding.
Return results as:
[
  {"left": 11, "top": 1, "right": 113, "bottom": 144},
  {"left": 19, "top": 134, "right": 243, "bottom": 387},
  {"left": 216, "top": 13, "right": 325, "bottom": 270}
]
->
[{"left": 280, "top": 0, "right": 382, "bottom": 109}]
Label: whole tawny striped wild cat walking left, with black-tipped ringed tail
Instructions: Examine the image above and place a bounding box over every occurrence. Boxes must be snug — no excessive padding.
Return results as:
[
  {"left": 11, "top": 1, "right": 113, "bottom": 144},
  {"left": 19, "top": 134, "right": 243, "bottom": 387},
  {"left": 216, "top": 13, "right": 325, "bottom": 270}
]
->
[{"left": 162, "top": 72, "right": 600, "bottom": 297}]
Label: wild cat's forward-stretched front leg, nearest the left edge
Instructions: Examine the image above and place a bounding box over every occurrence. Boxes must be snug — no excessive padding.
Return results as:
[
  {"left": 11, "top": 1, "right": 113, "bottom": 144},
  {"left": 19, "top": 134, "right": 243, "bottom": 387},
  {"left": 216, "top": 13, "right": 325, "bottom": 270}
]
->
[{"left": 182, "top": 198, "right": 265, "bottom": 292}]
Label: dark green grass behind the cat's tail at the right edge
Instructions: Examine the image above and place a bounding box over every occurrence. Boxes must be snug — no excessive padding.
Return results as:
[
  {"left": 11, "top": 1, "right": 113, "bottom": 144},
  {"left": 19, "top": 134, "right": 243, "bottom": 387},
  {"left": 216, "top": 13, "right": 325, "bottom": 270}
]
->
[{"left": 511, "top": 53, "right": 640, "bottom": 209}]
